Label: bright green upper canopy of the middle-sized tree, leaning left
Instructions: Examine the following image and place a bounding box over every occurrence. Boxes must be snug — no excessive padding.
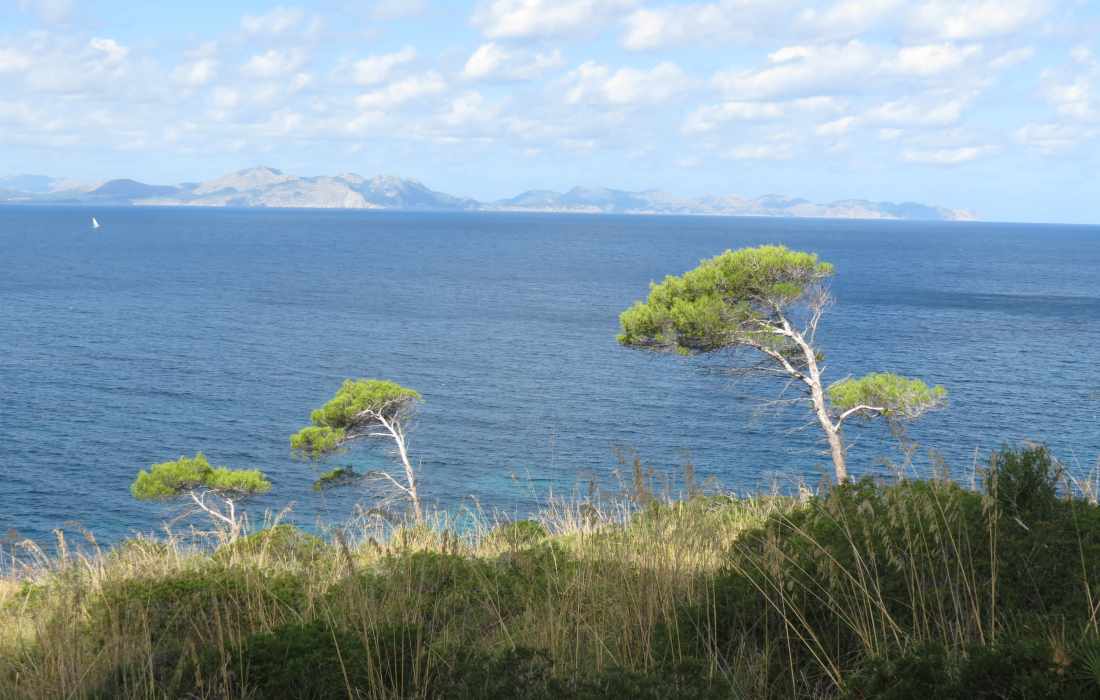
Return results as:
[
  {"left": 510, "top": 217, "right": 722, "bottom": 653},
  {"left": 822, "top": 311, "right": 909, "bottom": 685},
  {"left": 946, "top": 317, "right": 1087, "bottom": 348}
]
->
[{"left": 290, "top": 379, "right": 421, "bottom": 457}]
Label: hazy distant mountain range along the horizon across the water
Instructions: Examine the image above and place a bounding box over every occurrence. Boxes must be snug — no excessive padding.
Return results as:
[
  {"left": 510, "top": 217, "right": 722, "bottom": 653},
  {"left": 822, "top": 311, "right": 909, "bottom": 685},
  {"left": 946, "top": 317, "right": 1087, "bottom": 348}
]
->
[{"left": 0, "top": 167, "right": 976, "bottom": 221}]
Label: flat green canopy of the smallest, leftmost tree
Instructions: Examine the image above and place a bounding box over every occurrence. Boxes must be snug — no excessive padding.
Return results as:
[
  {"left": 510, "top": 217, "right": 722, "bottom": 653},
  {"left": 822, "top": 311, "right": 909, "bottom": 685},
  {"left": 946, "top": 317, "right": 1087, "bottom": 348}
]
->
[{"left": 130, "top": 452, "right": 272, "bottom": 501}]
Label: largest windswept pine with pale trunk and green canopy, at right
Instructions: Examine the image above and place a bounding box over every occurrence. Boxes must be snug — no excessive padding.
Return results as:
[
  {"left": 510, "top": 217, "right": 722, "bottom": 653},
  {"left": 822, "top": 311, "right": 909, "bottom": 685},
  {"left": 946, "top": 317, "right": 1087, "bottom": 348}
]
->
[{"left": 618, "top": 245, "right": 947, "bottom": 481}]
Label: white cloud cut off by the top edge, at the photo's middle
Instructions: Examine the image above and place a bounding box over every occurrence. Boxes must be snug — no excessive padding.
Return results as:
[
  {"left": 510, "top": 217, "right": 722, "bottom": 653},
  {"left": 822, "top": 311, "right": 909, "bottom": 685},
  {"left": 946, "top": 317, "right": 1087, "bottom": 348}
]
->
[{"left": 473, "top": 0, "right": 635, "bottom": 39}]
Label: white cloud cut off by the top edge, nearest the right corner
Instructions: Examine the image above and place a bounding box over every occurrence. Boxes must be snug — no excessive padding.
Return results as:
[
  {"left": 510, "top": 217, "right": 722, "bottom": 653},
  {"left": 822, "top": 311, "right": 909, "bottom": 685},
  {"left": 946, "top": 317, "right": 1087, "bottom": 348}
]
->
[{"left": 909, "top": 0, "right": 1049, "bottom": 40}]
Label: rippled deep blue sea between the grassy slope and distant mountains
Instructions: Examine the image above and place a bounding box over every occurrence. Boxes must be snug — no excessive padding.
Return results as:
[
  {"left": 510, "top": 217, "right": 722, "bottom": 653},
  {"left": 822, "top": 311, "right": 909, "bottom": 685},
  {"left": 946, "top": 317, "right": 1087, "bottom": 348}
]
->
[{"left": 0, "top": 207, "right": 1100, "bottom": 543}]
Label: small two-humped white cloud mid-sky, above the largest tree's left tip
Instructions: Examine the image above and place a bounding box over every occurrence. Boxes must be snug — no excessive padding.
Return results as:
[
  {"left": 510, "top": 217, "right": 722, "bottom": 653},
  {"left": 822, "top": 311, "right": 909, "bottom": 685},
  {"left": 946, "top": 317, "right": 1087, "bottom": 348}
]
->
[{"left": 565, "top": 61, "right": 692, "bottom": 106}]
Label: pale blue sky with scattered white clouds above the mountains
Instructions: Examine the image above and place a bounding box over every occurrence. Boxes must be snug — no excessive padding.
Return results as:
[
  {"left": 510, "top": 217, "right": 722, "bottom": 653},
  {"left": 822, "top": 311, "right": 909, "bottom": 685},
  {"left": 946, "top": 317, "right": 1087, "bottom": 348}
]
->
[{"left": 0, "top": 0, "right": 1100, "bottom": 223}]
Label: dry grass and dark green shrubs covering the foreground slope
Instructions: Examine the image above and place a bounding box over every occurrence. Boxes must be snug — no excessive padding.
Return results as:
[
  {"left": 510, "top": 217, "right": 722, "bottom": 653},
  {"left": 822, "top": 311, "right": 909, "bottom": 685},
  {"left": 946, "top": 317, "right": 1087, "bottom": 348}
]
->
[{"left": 0, "top": 447, "right": 1100, "bottom": 700}]
